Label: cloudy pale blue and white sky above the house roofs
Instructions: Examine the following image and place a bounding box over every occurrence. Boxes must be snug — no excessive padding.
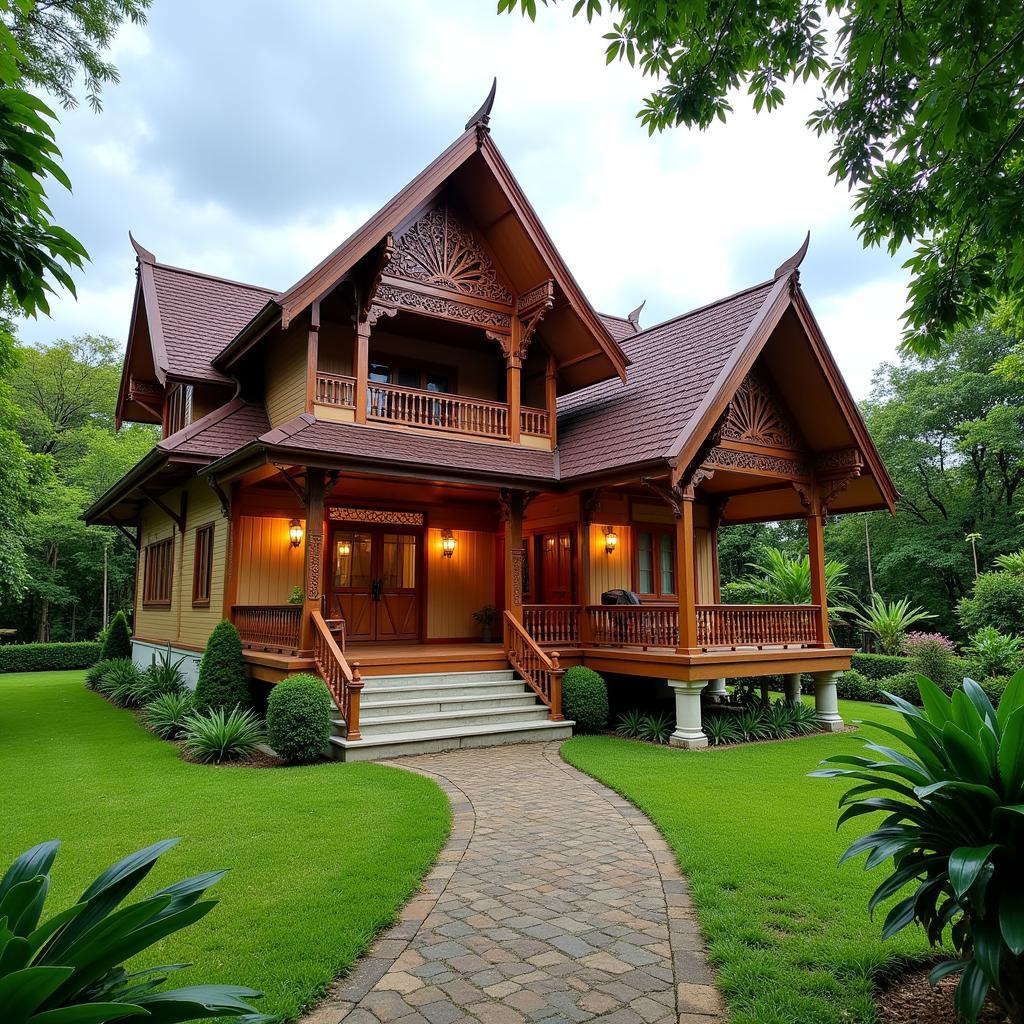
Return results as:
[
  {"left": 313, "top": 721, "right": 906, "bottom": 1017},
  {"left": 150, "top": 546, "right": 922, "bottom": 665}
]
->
[{"left": 22, "top": 0, "right": 906, "bottom": 397}]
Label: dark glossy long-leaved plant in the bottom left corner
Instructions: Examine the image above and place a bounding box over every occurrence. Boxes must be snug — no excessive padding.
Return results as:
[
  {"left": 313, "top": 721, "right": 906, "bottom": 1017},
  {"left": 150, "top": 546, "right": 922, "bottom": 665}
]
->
[{"left": 0, "top": 839, "right": 273, "bottom": 1024}]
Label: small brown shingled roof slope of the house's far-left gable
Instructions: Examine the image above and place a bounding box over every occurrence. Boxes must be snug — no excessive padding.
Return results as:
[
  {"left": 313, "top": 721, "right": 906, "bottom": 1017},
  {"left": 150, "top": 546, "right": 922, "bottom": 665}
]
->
[{"left": 150, "top": 263, "right": 278, "bottom": 382}]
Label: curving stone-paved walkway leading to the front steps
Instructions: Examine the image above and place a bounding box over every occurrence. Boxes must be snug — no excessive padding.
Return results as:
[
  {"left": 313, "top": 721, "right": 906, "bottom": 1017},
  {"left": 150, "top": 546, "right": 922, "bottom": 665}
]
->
[{"left": 305, "top": 743, "right": 724, "bottom": 1024}]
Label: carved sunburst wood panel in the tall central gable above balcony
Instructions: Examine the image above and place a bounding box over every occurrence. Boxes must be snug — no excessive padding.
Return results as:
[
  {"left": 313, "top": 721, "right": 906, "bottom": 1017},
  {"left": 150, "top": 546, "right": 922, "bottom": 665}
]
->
[{"left": 387, "top": 206, "right": 514, "bottom": 306}]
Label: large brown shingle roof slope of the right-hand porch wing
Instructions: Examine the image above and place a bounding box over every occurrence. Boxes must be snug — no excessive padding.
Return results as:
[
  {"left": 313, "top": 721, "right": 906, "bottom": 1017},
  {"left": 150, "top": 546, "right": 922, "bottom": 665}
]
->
[{"left": 558, "top": 281, "right": 775, "bottom": 479}]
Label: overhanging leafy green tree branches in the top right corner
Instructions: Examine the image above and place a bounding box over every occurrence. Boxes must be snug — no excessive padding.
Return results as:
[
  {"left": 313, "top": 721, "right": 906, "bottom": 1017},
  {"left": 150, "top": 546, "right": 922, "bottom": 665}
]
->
[{"left": 498, "top": 0, "right": 1024, "bottom": 354}]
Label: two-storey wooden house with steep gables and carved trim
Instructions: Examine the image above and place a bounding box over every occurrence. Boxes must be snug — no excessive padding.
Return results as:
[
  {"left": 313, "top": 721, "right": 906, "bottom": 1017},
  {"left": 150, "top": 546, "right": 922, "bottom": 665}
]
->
[{"left": 87, "top": 93, "right": 896, "bottom": 758}]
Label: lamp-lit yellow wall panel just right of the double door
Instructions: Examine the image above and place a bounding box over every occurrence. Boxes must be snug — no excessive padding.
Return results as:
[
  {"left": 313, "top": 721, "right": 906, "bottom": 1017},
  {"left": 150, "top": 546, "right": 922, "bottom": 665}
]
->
[{"left": 425, "top": 527, "right": 496, "bottom": 640}]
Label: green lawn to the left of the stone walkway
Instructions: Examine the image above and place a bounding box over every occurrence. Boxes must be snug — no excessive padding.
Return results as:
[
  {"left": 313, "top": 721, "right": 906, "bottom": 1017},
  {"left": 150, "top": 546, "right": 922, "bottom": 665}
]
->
[{"left": 0, "top": 672, "right": 451, "bottom": 1019}]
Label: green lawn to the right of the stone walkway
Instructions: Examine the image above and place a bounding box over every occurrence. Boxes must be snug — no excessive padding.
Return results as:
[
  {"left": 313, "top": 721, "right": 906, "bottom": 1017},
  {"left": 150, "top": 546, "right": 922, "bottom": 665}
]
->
[{"left": 562, "top": 701, "right": 928, "bottom": 1024}]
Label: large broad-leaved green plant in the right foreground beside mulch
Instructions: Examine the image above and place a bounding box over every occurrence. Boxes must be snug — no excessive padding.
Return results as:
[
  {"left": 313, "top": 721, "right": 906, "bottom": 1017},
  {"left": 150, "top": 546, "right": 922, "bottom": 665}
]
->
[{"left": 812, "top": 672, "right": 1024, "bottom": 1024}]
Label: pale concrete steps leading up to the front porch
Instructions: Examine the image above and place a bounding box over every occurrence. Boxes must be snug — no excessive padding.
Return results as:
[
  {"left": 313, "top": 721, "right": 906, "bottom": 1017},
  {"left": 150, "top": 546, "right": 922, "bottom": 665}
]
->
[{"left": 331, "top": 669, "right": 572, "bottom": 761}]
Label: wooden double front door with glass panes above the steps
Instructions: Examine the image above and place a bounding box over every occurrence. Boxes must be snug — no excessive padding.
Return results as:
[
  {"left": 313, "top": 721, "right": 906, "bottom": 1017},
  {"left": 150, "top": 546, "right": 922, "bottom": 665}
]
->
[{"left": 328, "top": 523, "right": 423, "bottom": 642}]
